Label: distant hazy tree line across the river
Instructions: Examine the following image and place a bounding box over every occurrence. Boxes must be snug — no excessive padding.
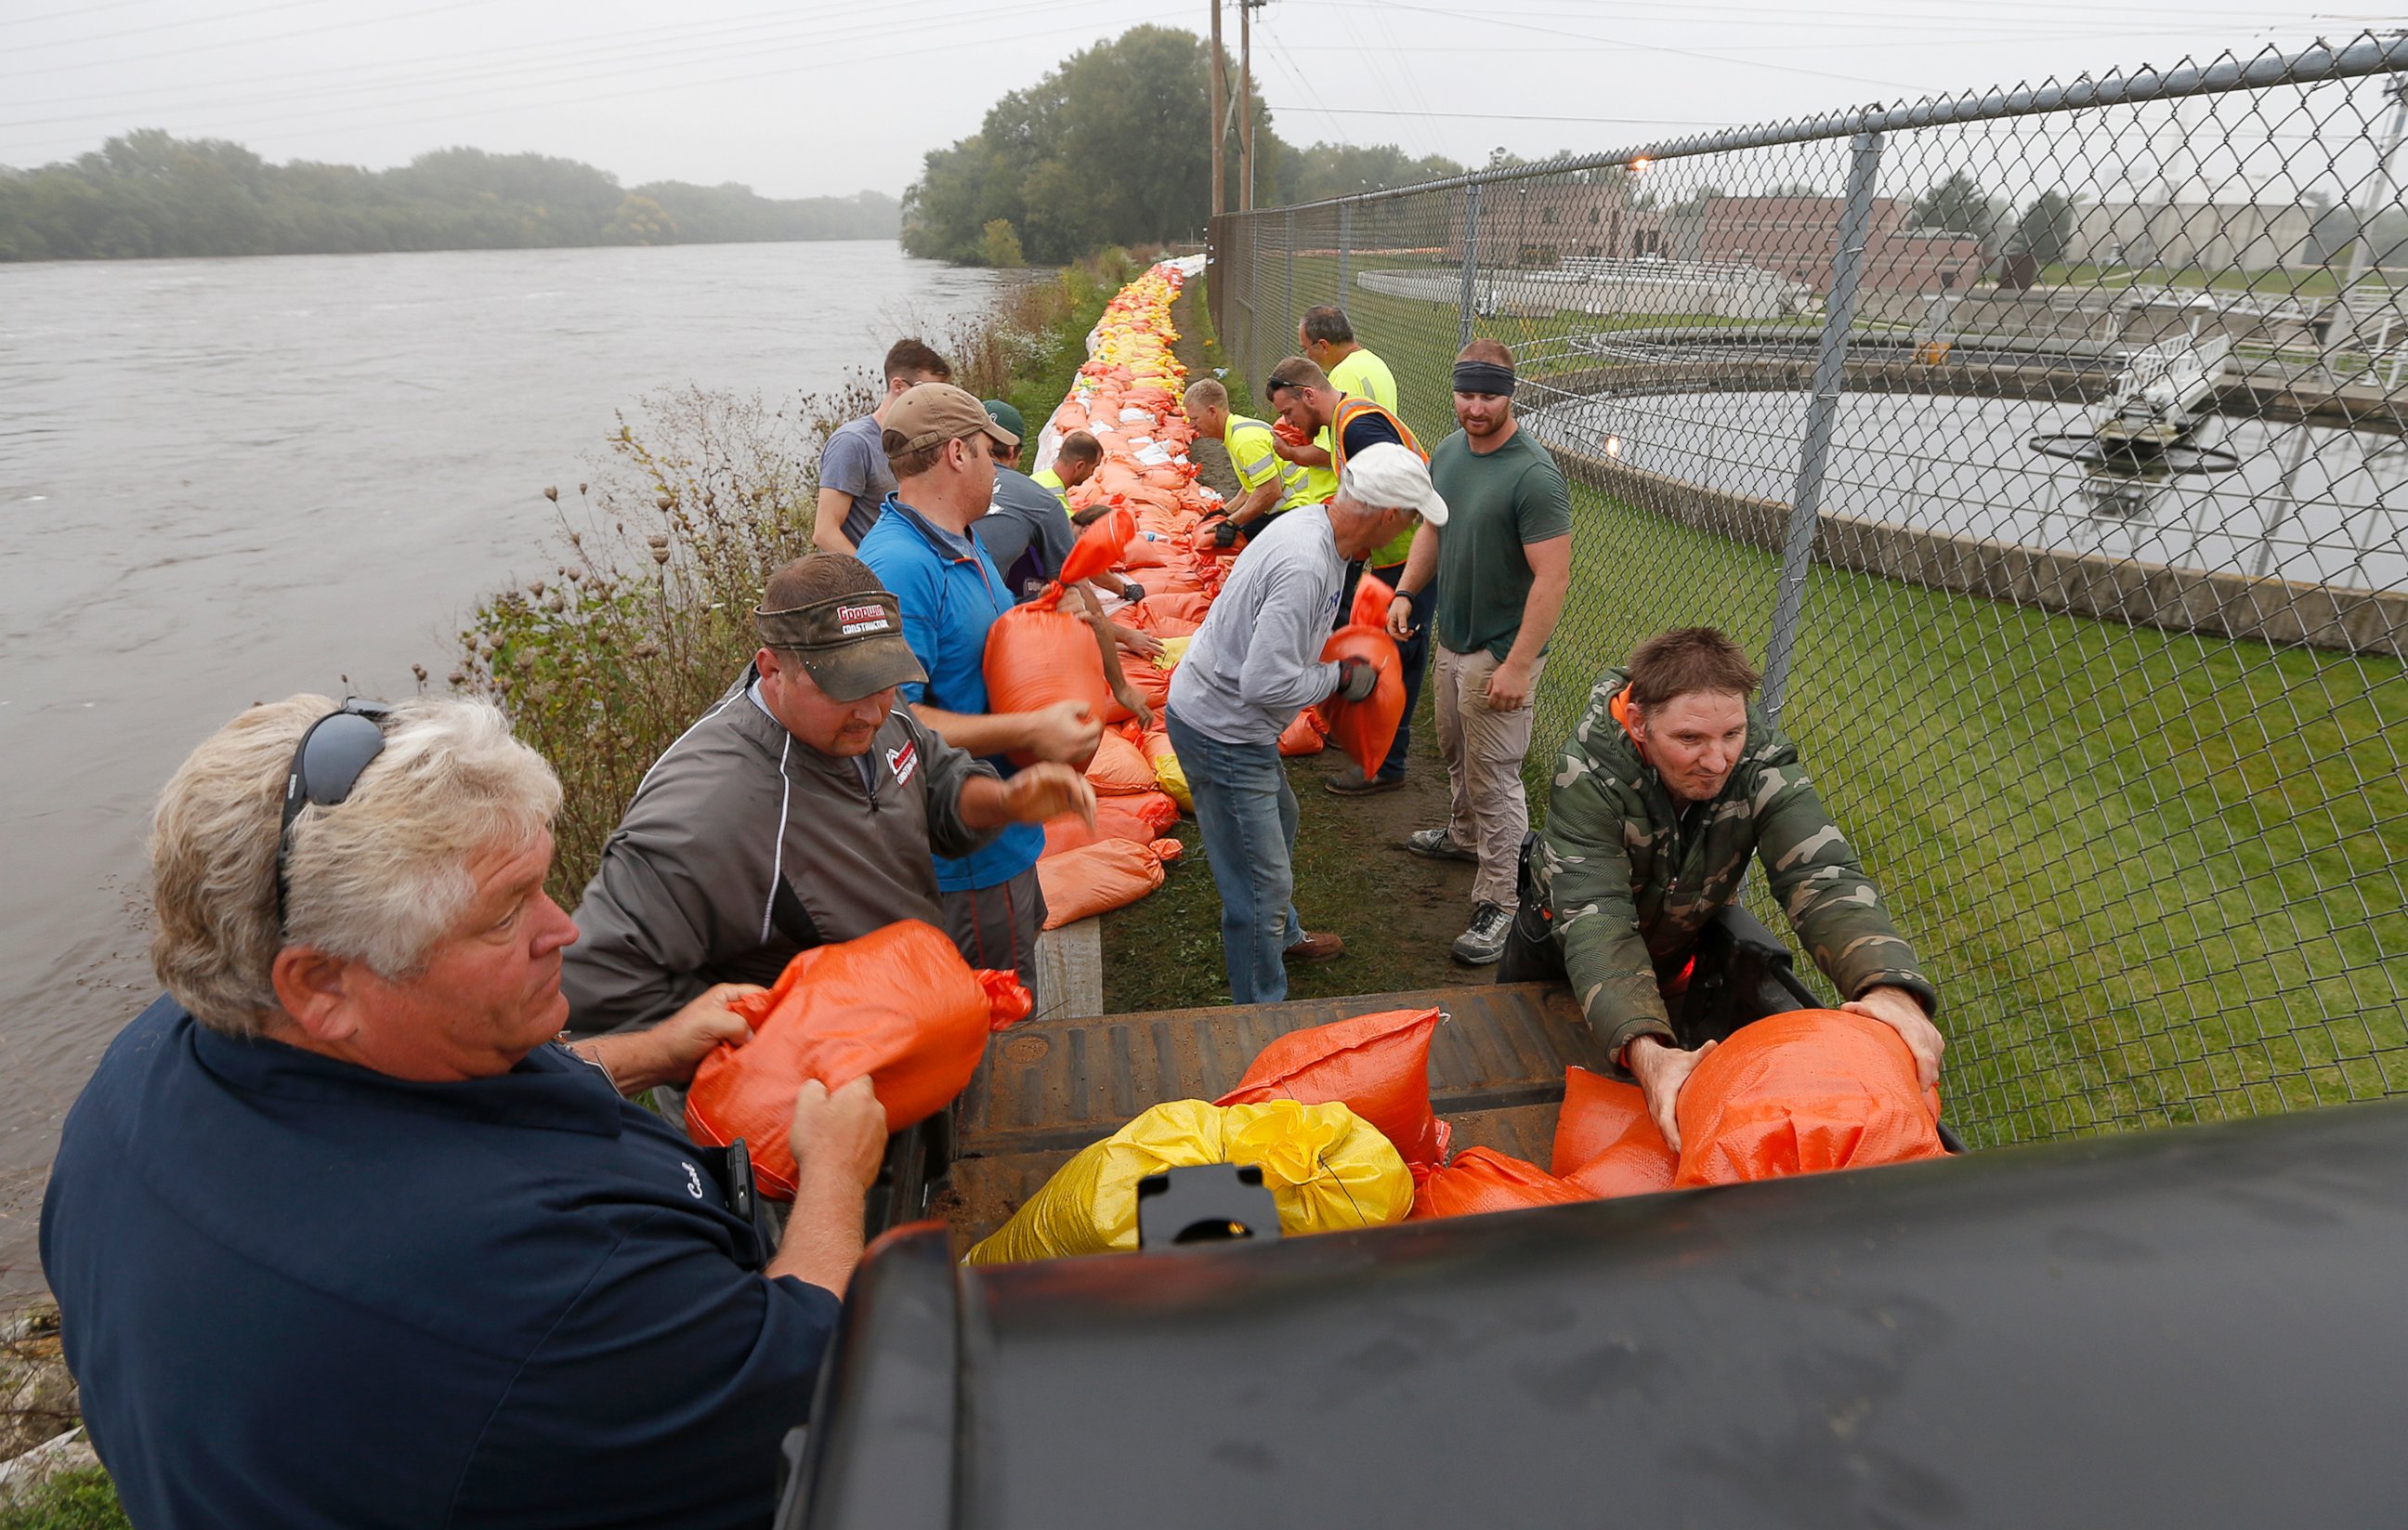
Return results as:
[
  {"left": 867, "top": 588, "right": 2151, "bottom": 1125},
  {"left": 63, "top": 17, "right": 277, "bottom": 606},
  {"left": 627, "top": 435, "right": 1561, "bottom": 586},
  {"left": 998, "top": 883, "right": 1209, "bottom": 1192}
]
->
[{"left": 0, "top": 127, "right": 898, "bottom": 260}]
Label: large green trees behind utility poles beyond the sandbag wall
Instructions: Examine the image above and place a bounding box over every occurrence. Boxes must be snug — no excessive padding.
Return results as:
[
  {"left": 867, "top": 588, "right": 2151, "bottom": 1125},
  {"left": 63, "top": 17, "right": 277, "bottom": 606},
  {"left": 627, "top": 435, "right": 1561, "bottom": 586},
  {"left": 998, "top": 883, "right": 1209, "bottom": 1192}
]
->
[{"left": 903, "top": 27, "right": 1464, "bottom": 265}]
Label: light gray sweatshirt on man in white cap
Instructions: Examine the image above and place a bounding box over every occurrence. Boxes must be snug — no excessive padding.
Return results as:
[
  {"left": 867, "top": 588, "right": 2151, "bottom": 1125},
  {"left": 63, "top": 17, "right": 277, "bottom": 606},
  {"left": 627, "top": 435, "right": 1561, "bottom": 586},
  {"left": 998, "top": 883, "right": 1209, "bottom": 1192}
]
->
[{"left": 1171, "top": 503, "right": 1346, "bottom": 744}]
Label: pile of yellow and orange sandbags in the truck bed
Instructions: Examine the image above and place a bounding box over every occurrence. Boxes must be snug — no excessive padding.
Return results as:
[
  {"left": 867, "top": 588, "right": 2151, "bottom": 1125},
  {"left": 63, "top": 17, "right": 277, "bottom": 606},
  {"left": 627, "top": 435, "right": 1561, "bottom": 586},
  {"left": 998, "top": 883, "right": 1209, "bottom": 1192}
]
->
[{"left": 949, "top": 1010, "right": 1943, "bottom": 1262}]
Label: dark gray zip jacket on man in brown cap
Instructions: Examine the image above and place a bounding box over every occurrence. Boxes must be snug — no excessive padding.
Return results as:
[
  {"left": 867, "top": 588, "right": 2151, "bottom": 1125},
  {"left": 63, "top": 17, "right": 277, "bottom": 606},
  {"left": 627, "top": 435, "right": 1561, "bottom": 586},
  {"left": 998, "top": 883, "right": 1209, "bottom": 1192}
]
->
[{"left": 561, "top": 667, "right": 997, "bottom": 1036}]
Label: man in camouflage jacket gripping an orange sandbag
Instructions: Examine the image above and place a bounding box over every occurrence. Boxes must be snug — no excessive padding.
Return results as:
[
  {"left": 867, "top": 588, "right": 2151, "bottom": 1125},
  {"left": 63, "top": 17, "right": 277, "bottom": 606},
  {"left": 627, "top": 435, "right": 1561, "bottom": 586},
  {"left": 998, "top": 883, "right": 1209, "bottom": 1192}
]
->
[{"left": 1532, "top": 626, "right": 1943, "bottom": 1147}]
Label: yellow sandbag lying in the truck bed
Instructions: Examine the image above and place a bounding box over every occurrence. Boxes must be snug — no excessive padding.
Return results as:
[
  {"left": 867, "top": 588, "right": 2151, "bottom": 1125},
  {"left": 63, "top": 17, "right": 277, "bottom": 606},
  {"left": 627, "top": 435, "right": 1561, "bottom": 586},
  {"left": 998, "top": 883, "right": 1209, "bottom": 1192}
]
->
[{"left": 965, "top": 1099, "right": 1414, "bottom": 1265}]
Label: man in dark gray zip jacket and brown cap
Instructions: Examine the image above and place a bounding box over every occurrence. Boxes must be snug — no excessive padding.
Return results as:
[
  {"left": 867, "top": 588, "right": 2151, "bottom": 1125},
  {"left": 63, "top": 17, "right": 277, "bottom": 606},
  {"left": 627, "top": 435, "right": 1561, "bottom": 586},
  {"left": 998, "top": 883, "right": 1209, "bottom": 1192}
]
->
[{"left": 561, "top": 552, "right": 1095, "bottom": 1036}]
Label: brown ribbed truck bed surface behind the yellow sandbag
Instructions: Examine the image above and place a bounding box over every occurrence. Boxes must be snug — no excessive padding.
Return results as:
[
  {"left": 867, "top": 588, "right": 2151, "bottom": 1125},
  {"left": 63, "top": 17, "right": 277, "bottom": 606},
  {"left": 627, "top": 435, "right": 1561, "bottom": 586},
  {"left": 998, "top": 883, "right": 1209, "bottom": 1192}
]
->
[{"left": 935, "top": 983, "right": 1599, "bottom": 1250}]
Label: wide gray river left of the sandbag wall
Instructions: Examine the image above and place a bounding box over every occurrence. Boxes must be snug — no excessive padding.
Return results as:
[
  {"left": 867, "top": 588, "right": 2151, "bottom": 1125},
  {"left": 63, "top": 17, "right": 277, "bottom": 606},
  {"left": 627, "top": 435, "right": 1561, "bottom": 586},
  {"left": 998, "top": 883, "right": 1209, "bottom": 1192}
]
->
[{"left": 0, "top": 241, "right": 994, "bottom": 1301}]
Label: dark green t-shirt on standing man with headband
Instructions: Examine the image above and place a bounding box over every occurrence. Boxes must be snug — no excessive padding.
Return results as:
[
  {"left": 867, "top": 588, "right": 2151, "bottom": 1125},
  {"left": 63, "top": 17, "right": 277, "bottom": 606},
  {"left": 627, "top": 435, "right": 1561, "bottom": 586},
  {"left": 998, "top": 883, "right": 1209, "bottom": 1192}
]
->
[{"left": 1431, "top": 431, "right": 1573, "bottom": 658}]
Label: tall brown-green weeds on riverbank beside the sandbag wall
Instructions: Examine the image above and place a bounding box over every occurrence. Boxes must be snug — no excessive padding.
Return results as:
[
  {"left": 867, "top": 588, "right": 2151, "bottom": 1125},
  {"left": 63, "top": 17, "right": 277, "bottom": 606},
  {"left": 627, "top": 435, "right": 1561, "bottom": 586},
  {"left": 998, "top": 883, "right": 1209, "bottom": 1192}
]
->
[{"left": 451, "top": 251, "right": 1144, "bottom": 906}]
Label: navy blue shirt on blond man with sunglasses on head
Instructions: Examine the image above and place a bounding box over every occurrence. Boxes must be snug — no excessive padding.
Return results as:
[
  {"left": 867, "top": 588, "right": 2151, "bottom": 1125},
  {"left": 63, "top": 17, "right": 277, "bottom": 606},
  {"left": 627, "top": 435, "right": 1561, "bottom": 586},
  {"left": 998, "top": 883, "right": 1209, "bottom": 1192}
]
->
[{"left": 41, "top": 998, "right": 838, "bottom": 1530}]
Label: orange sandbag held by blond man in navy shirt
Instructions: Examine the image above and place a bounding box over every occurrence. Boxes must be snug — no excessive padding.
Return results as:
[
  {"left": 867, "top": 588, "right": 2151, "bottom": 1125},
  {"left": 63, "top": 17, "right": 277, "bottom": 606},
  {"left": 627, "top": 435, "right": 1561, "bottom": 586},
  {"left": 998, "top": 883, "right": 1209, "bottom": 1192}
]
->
[{"left": 687, "top": 921, "right": 1028, "bottom": 1200}]
